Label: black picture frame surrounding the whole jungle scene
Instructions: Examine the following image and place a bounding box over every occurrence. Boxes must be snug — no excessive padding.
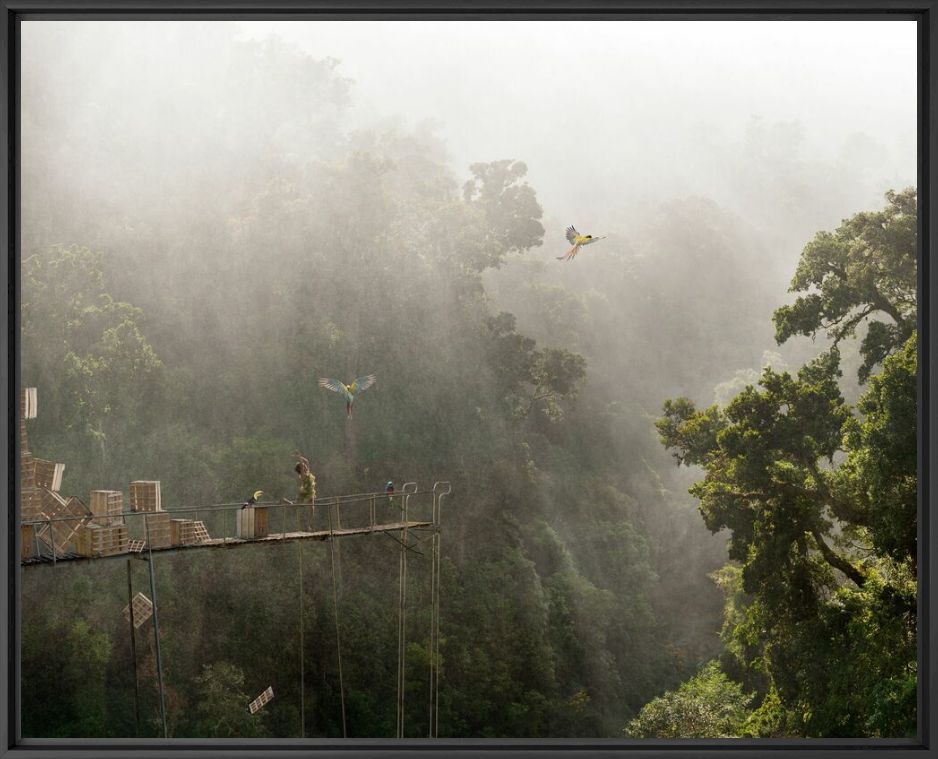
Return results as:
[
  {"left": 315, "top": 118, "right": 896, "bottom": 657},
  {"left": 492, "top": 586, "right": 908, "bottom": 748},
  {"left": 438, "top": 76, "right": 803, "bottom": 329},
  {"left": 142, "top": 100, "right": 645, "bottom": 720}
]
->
[{"left": 0, "top": 0, "right": 938, "bottom": 759}]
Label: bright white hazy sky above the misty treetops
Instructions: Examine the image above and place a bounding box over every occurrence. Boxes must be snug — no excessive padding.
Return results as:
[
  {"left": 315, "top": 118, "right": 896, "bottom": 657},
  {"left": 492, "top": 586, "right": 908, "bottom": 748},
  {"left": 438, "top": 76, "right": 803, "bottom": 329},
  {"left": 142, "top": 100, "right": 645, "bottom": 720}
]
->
[{"left": 239, "top": 21, "right": 916, "bottom": 218}]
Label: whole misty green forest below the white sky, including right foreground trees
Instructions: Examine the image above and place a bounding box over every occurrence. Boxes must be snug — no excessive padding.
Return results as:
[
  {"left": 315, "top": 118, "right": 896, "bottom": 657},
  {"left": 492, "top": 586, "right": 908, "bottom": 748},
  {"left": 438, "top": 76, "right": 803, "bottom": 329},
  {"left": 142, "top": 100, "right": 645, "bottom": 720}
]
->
[{"left": 21, "top": 22, "right": 917, "bottom": 738}]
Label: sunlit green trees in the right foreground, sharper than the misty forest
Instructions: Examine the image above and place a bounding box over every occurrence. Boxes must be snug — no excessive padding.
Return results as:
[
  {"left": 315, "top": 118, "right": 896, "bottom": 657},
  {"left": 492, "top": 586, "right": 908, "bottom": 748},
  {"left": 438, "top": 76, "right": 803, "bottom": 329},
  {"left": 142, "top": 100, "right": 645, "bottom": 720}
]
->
[{"left": 643, "top": 190, "right": 917, "bottom": 736}]
